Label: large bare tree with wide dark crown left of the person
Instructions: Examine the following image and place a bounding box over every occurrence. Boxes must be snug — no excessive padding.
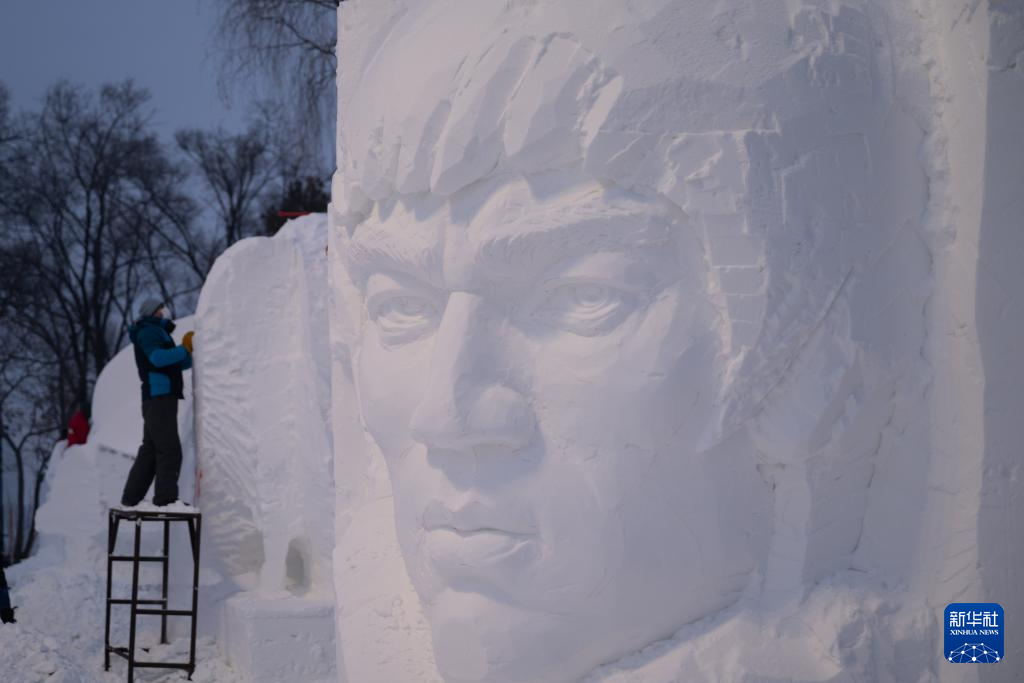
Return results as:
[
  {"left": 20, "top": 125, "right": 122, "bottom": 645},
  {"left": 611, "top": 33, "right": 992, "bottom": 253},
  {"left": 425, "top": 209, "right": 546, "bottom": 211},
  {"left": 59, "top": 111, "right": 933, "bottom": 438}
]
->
[{"left": 0, "top": 82, "right": 193, "bottom": 411}]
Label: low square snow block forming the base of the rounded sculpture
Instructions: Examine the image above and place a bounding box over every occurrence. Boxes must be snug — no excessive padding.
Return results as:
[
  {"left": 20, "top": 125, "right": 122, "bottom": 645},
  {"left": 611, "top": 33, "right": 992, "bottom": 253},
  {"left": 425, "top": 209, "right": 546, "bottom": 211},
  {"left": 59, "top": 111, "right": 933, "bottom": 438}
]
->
[{"left": 221, "top": 592, "right": 337, "bottom": 683}]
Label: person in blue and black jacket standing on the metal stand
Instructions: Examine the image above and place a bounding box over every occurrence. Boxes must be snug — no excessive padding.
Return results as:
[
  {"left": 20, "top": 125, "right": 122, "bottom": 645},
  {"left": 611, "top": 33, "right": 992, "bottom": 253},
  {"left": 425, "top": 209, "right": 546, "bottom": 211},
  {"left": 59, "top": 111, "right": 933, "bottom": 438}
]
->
[{"left": 121, "top": 299, "right": 193, "bottom": 507}]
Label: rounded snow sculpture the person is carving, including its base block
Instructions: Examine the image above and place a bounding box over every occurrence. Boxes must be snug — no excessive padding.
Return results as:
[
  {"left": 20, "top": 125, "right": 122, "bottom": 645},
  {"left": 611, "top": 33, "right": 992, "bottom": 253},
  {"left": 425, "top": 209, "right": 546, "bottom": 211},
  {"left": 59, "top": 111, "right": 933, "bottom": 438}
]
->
[{"left": 196, "top": 216, "right": 335, "bottom": 683}]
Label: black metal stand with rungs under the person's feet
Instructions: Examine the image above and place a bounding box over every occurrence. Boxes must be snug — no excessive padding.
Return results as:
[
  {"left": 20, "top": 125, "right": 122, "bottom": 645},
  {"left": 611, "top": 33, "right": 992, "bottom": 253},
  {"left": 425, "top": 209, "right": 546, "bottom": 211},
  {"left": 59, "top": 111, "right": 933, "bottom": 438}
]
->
[{"left": 103, "top": 508, "right": 203, "bottom": 683}]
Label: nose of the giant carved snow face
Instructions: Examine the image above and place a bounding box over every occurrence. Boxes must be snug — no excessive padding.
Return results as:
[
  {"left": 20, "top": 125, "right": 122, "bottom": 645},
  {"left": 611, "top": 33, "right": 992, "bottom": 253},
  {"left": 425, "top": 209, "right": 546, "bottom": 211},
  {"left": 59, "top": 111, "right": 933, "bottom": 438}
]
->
[{"left": 410, "top": 292, "right": 535, "bottom": 451}]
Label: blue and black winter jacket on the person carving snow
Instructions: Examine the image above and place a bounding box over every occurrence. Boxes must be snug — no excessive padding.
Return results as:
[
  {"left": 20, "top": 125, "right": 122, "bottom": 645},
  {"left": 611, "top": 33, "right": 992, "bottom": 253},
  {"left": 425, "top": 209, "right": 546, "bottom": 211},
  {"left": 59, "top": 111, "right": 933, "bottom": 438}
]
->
[{"left": 128, "top": 316, "right": 191, "bottom": 400}]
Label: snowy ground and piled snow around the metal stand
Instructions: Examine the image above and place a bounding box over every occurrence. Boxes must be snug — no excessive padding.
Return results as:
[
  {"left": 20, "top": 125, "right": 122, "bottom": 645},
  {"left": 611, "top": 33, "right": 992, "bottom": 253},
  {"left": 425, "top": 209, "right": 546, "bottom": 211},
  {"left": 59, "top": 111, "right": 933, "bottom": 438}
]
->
[{"left": 0, "top": 445, "right": 242, "bottom": 683}]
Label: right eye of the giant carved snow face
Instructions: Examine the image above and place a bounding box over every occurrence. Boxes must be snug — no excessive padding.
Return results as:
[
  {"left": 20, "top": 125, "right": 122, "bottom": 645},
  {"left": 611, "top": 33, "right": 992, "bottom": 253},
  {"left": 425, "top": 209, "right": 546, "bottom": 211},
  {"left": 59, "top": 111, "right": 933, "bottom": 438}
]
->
[{"left": 535, "top": 283, "right": 636, "bottom": 337}]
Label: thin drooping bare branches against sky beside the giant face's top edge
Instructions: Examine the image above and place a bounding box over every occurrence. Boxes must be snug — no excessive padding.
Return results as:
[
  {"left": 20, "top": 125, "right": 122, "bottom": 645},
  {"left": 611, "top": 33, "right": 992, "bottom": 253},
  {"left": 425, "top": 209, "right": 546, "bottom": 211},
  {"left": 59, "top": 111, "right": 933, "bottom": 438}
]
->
[{"left": 211, "top": 0, "right": 341, "bottom": 165}]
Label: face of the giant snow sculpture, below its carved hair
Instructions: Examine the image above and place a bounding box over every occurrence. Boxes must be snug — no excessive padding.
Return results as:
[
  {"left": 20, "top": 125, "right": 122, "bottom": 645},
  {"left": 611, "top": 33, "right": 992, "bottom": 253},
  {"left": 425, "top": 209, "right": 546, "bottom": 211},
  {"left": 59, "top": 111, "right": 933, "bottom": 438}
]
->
[{"left": 351, "top": 169, "right": 765, "bottom": 681}]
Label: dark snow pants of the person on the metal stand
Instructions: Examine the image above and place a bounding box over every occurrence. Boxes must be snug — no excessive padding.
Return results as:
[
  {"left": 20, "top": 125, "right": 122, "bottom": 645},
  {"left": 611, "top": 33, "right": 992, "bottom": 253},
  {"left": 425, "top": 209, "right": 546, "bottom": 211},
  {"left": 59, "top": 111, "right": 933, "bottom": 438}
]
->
[{"left": 121, "top": 395, "right": 181, "bottom": 505}]
